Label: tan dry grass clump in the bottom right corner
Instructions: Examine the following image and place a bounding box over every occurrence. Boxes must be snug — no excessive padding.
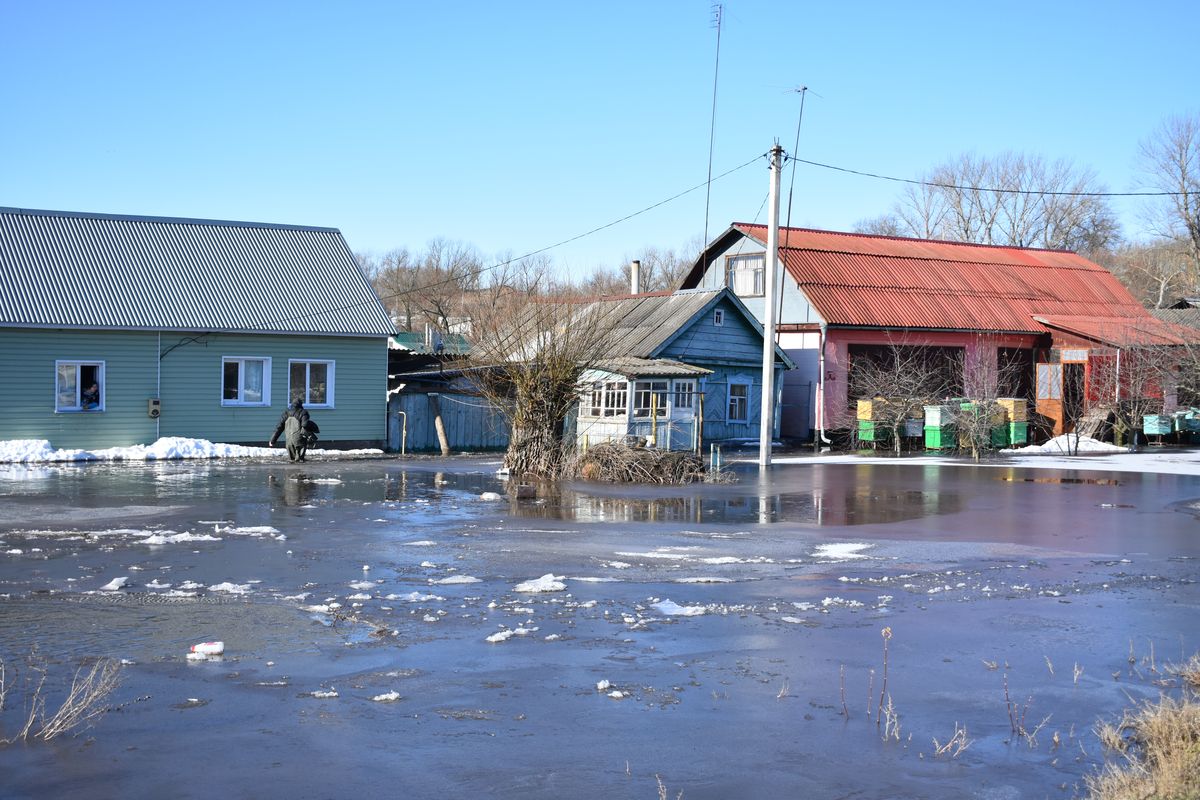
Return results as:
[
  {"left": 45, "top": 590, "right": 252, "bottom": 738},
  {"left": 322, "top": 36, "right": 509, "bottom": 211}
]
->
[{"left": 1087, "top": 690, "right": 1200, "bottom": 800}]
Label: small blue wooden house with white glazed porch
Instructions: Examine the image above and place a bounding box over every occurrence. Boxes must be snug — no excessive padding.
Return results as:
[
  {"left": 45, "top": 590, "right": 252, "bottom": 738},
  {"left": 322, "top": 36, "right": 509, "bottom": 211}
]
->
[{"left": 576, "top": 289, "right": 794, "bottom": 450}]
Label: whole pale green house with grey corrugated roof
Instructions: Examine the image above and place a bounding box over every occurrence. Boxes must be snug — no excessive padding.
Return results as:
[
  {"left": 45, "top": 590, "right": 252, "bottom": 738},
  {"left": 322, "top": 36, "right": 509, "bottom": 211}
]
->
[{"left": 0, "top": 207, "right": 396, "bottom": 449}]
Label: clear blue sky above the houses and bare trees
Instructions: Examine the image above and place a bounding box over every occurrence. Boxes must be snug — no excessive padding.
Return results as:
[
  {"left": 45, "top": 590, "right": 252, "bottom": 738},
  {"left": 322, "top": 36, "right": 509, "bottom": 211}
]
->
[{"left": 0, "top": 0, "right": 1200, "bottom": 275}]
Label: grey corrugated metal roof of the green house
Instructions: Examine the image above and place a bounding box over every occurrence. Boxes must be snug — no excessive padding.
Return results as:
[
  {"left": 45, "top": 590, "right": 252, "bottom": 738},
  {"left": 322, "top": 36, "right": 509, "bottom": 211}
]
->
[{"left": 0, "top": 207, "right": 396, "bottom": 336}]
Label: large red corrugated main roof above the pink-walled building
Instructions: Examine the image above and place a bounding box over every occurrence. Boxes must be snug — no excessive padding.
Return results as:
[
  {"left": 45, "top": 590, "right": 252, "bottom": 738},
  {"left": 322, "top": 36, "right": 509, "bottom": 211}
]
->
[{"left": 733, "top": 223, "right": 1152, "bottom": 333}]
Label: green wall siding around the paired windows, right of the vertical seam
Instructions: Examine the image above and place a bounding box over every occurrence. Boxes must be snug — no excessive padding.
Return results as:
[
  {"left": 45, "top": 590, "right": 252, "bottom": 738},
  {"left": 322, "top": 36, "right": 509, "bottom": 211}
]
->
[{"left": 161, "top": 333, "right": 388, "bottom": 446}]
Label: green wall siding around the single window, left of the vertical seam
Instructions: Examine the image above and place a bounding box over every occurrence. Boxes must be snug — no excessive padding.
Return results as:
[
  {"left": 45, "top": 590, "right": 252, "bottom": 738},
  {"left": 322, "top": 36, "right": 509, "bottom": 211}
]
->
[{"left": 0, "top": 327, "right": 158, "bottom": 450}]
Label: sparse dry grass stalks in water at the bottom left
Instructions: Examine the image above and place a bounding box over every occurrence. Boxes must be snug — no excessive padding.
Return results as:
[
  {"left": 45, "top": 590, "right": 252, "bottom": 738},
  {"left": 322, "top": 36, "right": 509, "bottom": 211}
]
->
[{"left": 0, "top": 650, "right": 121, "bottom": 745}]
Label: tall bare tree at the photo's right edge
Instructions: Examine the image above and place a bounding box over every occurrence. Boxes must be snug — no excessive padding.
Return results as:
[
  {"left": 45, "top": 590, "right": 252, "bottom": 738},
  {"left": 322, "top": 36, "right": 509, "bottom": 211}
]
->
[{"left": 1140, "top": 114, "right": 1200, "bottom": 288}]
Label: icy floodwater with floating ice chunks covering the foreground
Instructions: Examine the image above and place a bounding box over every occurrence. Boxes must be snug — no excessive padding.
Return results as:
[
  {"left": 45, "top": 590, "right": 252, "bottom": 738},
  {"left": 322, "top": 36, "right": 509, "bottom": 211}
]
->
[{"left": 0, "top": 459, "right": 1200, "bottom": 800}]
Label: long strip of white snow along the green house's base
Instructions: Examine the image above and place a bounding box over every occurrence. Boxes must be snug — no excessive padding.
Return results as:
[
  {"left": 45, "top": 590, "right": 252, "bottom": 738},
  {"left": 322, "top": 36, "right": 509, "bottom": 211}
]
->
[{"left": 0, "top": 437, "right": 383, "bottom": 463}]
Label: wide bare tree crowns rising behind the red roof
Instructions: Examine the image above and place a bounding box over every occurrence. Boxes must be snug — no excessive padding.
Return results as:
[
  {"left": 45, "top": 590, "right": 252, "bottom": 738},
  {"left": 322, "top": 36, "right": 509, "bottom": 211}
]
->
[{"left": 858, "top": 152, "right": 1118, "bottom": 253}]
